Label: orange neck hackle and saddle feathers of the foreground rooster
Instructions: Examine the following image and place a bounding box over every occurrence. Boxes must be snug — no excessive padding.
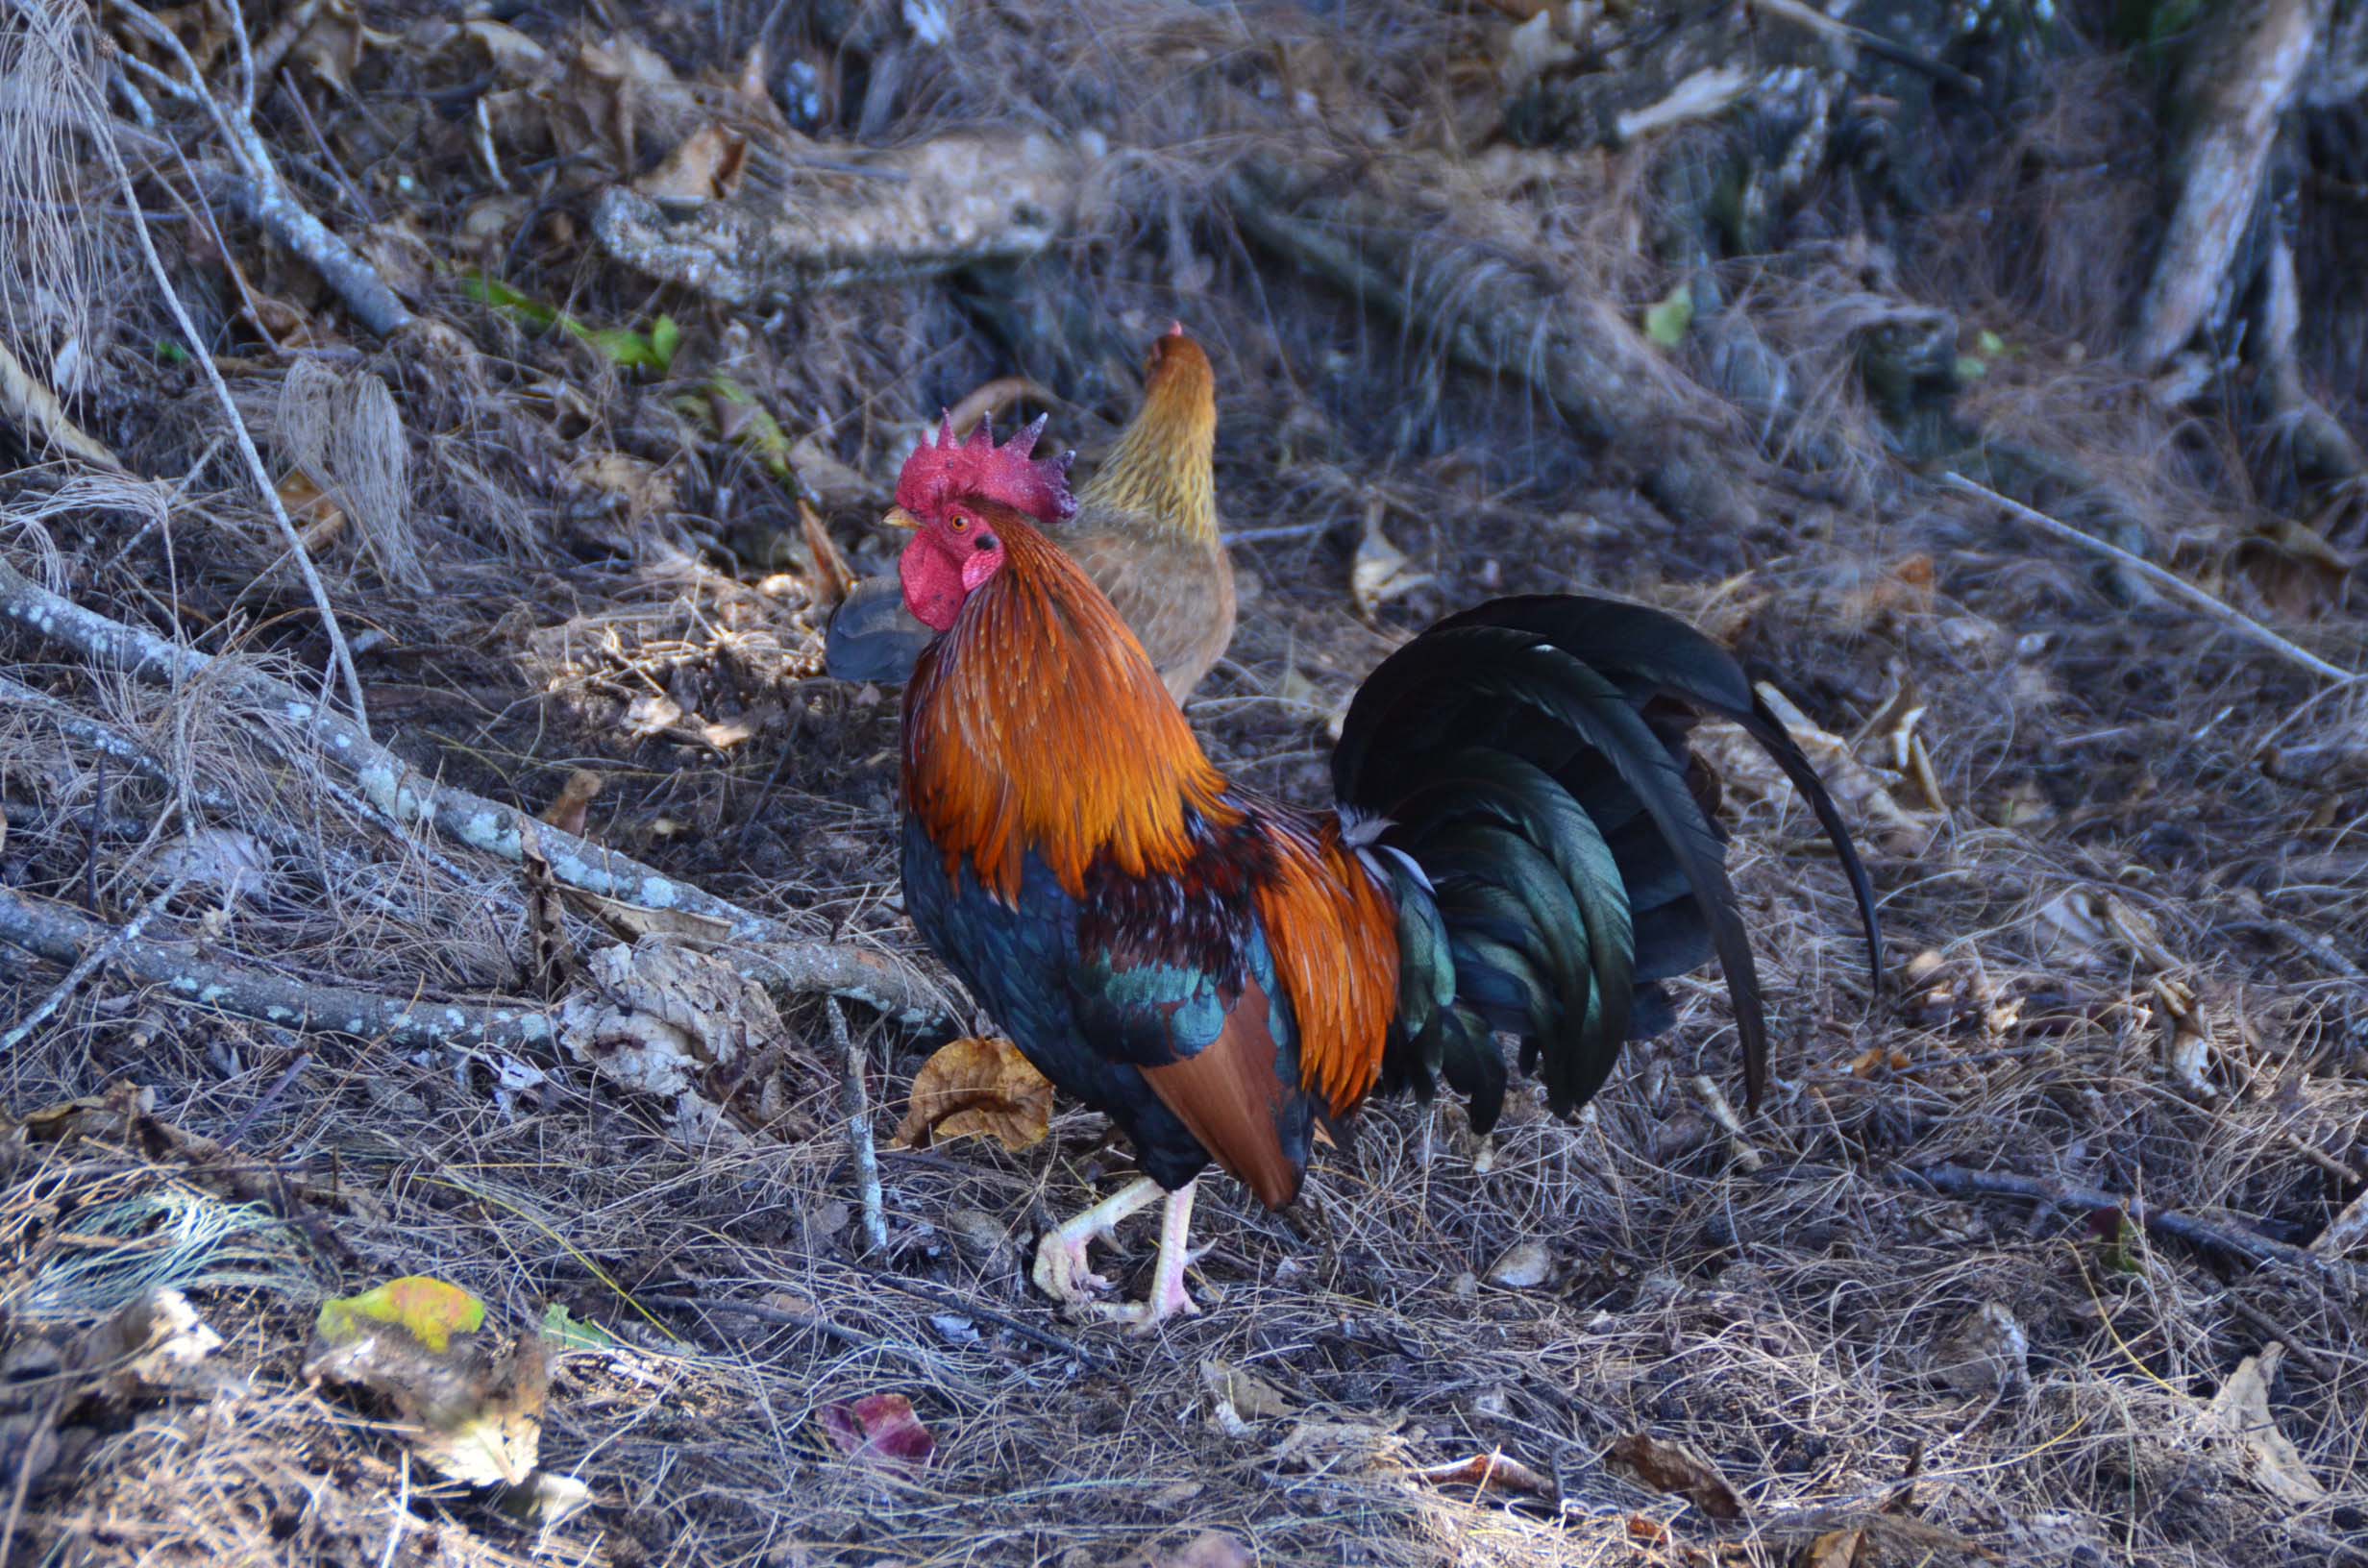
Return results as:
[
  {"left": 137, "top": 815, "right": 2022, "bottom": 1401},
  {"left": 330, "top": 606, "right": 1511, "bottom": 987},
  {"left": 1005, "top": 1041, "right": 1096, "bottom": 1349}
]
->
[{"left": 904, "top": 504, "right": 1397, "bottom": 1115}]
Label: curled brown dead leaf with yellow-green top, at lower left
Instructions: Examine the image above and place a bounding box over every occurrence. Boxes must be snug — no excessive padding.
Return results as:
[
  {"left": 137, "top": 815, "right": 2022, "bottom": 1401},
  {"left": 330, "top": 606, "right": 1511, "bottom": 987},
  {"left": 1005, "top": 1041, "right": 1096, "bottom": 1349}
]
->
[{"left": 303, "top": 1277, "right": 550, "bottom": 1485}]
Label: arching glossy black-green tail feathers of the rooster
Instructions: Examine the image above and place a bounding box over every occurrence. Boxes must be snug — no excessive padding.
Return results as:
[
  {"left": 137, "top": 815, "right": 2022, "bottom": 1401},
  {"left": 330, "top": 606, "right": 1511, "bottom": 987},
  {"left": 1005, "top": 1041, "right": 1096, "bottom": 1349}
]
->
[{"left": 1333, "top": 595, "right": 1883, "bottom": 1130}]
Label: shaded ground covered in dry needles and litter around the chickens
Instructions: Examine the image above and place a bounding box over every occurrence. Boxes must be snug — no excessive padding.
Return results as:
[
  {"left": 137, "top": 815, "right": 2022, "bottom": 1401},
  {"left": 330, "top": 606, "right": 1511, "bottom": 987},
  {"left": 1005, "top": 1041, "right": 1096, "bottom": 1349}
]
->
[{"left": 0, "top": 0, "right": 2368, "bottom": 1568}]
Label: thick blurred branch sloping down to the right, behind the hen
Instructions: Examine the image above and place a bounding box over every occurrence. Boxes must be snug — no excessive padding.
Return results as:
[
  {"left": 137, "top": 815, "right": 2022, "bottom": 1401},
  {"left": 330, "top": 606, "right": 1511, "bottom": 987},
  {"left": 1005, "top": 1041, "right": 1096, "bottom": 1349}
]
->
[{"left": 1226, "top": 159, "right": 1757, "bottom": 530}]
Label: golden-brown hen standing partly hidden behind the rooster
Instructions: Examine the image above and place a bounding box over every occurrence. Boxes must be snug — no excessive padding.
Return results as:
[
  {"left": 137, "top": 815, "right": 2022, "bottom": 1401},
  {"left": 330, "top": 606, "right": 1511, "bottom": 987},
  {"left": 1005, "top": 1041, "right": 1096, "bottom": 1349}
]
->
[{"left": 824, "top": 322, "right": 1234, "bottom": 703}]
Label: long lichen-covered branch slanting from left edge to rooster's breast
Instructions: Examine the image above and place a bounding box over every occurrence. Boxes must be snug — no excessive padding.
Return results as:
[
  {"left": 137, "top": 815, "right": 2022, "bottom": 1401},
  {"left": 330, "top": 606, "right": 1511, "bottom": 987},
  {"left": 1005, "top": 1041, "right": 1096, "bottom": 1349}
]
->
[{"left": 0, "top": 561, "right": 945, "bottom": 1023}]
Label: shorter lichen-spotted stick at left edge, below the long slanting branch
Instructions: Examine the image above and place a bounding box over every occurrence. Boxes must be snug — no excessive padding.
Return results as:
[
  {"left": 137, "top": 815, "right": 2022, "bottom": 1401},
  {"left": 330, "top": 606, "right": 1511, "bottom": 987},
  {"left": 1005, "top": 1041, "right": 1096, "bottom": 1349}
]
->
[{"left": 0, "top": 884, "right": 552, "bottom": 1052}]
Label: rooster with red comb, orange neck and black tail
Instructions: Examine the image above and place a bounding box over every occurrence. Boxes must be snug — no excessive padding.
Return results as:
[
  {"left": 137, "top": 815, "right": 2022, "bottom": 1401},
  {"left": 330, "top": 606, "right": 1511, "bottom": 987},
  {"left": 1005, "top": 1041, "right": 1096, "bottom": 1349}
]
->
[{"left": 890, "top": 426, "right": 1883, "bottom": 1327}]
